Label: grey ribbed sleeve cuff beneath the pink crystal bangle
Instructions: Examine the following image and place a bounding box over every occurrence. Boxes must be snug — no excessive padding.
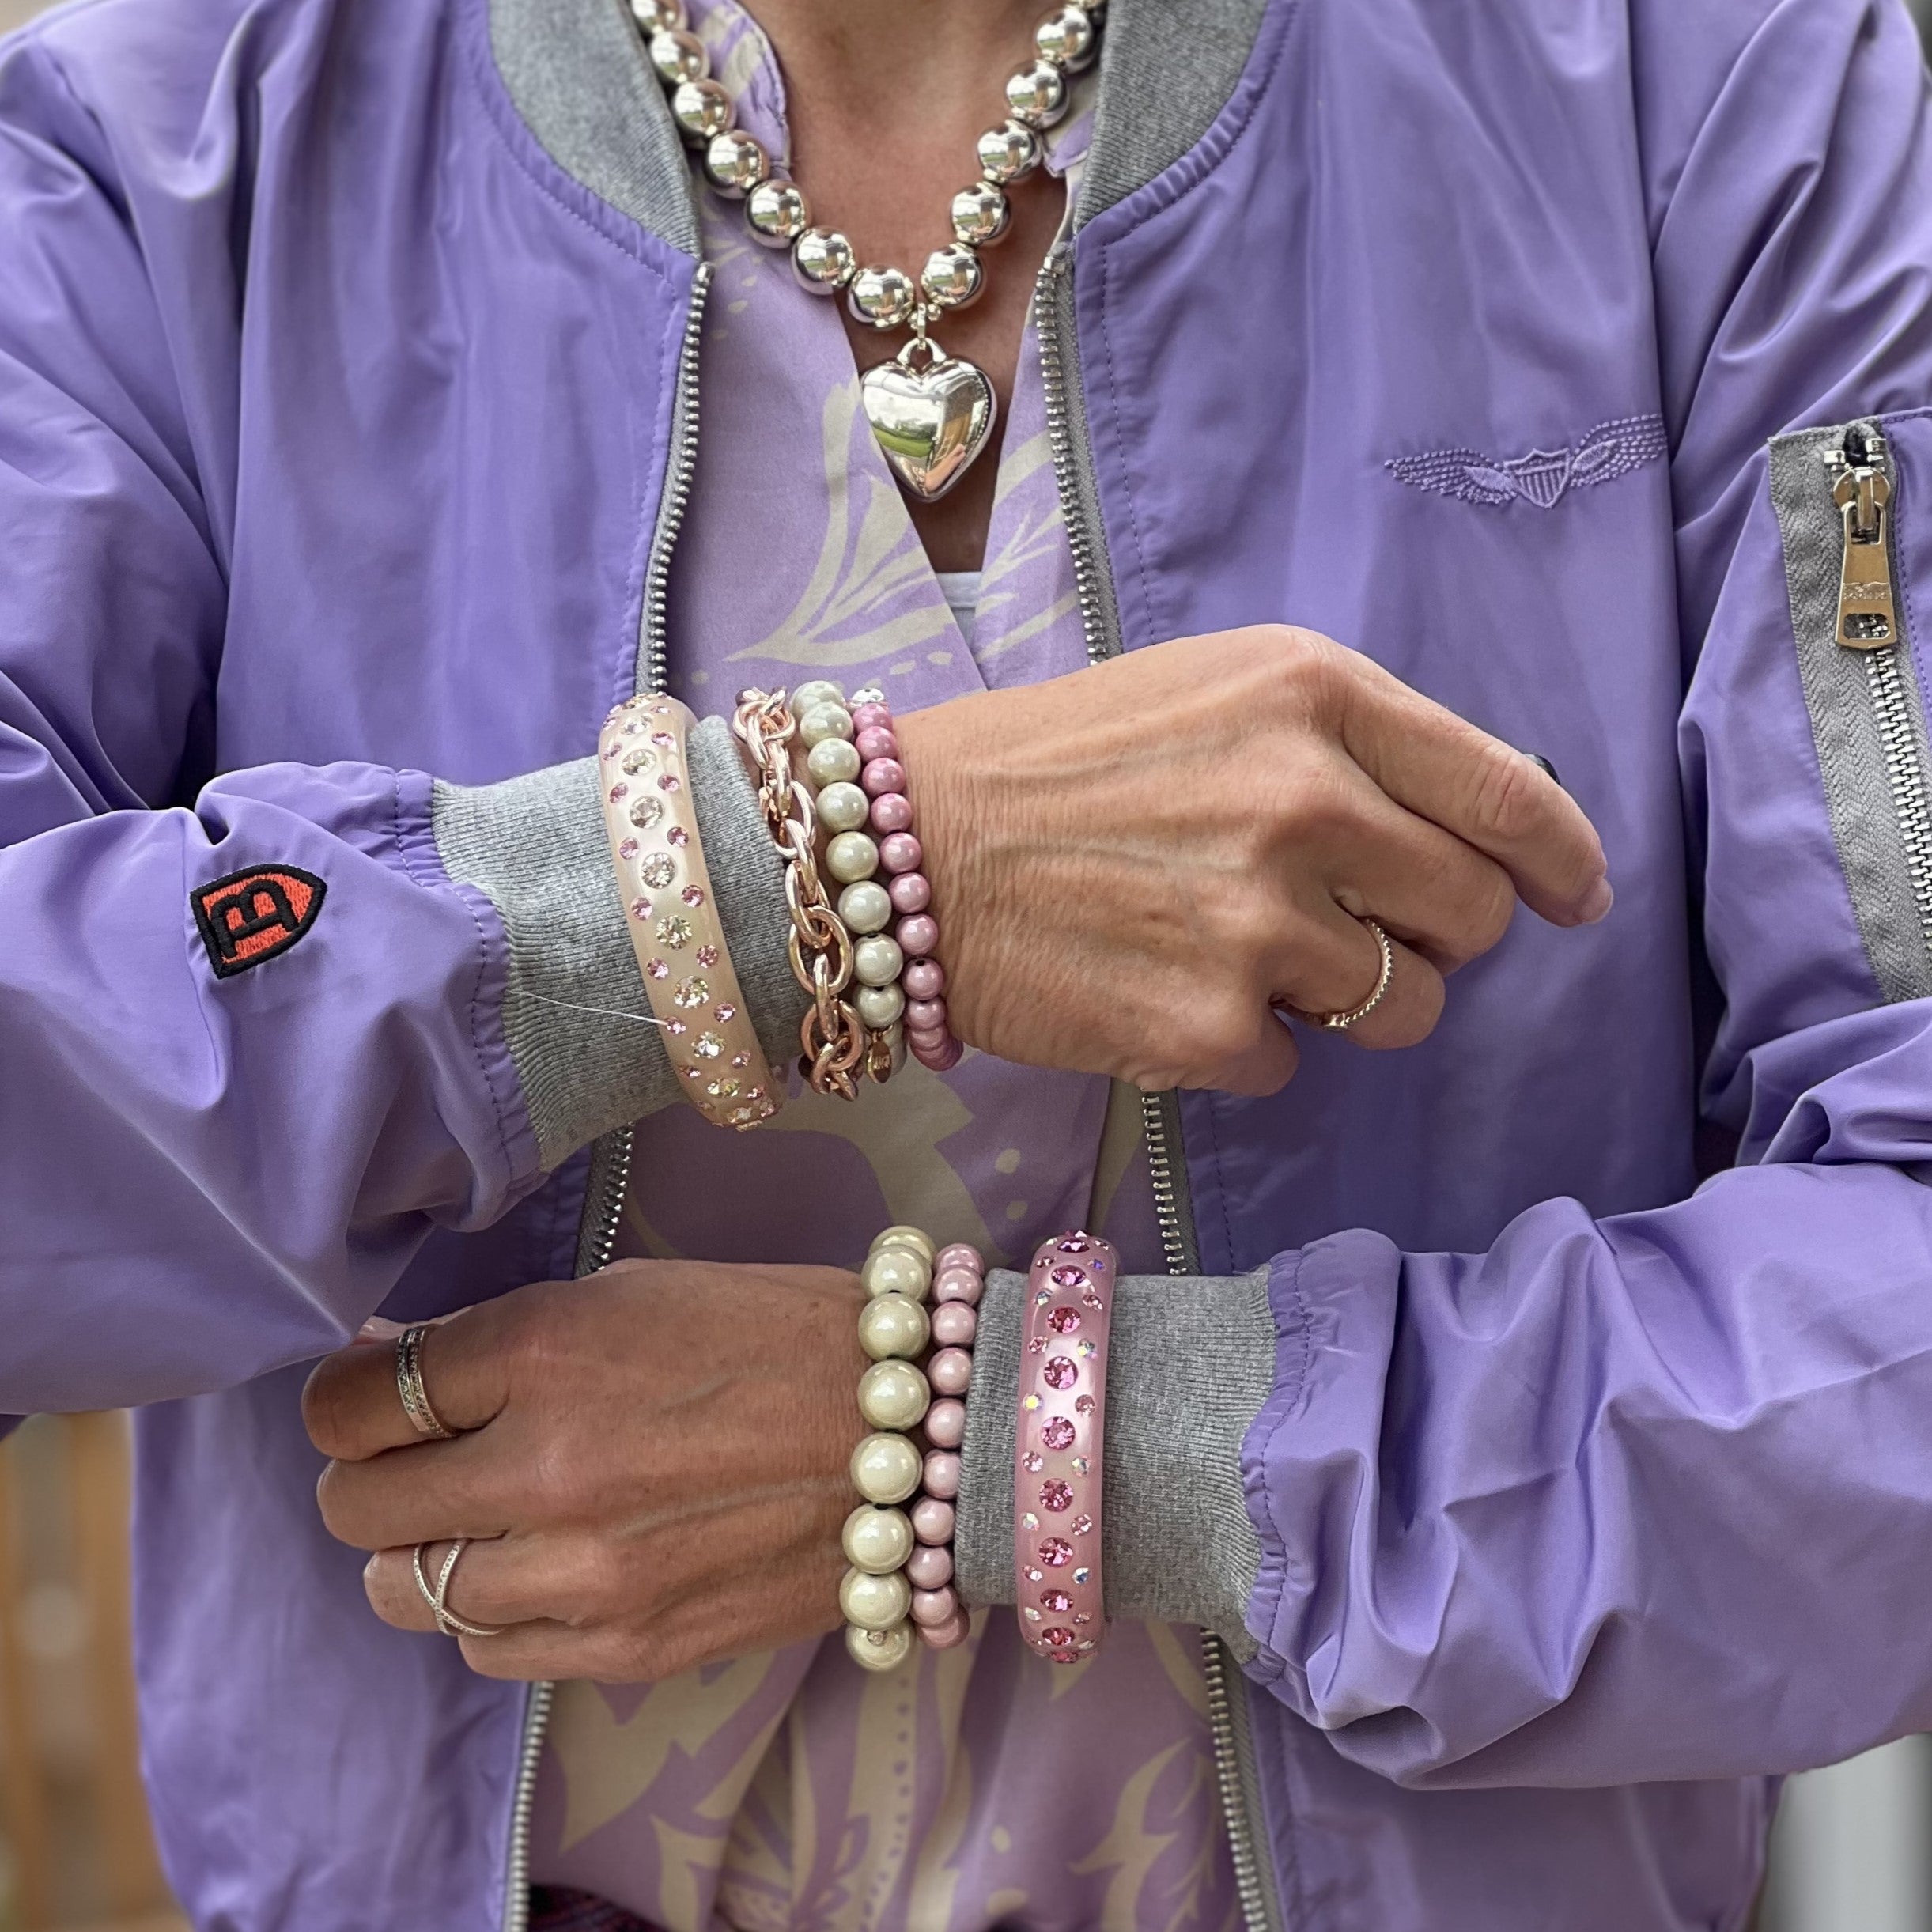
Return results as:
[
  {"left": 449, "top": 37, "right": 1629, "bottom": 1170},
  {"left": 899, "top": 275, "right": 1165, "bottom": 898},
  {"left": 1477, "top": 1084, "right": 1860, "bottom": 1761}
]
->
[{"left": 952, "top": 1269, "right": 1275, "bottom": 1662}]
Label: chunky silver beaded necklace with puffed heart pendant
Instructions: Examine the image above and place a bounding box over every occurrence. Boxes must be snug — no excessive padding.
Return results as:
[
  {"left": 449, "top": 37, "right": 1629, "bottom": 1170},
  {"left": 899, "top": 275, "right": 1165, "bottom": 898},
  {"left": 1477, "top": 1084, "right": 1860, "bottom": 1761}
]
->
[{"left": 630, "top": 0, "right": 1105, "bottom": 502}]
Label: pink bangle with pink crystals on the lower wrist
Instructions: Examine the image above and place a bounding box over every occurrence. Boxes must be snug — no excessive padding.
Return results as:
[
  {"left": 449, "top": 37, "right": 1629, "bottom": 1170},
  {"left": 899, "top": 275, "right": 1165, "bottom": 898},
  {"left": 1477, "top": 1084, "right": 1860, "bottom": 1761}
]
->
[{"left": 1012, "top": 1229, "right": 1121, "bottom": 1663}]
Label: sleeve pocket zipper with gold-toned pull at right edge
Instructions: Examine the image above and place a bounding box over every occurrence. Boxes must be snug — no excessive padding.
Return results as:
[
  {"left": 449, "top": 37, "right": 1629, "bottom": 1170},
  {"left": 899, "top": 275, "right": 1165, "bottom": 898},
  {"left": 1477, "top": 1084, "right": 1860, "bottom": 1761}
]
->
[{"left": 1826, "top": 423, "right": 1932, "bottom": 951}]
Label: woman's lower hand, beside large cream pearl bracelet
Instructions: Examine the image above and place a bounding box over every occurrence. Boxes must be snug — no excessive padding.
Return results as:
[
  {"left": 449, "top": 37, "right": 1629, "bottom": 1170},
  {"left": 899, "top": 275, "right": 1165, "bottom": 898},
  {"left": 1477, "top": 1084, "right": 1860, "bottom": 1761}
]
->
[{"left": 304, "top": 1261, "right": 865, "bottom": 1681}]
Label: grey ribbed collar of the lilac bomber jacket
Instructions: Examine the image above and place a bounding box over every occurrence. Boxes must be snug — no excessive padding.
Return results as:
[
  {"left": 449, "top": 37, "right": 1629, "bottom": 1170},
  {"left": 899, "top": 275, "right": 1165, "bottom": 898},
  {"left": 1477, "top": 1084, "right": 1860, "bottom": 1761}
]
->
[{"left": 489, "top": 0, "right": 1287, "bottom": 259}]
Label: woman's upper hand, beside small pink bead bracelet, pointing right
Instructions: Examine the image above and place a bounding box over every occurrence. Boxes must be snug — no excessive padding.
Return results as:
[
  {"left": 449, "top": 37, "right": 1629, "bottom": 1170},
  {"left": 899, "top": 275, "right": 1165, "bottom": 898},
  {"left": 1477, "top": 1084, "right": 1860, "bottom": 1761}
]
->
[{"left": 894, "top": 626, "right": 1611, "bottom": 1094}]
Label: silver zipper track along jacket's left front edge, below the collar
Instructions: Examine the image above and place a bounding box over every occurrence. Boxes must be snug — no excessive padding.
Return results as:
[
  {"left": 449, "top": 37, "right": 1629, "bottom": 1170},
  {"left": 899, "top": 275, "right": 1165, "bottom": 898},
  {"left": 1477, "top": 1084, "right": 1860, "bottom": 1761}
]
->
[{"left": 502, "top": 261, "right": 711, "bottom": 1932}]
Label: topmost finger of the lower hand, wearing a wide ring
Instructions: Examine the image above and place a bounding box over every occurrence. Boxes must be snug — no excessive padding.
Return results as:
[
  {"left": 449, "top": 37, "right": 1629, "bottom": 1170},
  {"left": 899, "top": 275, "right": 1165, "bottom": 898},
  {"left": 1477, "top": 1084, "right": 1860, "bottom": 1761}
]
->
[{"left": 301, "top": 1296, "right": 516, "bottom": 1462}]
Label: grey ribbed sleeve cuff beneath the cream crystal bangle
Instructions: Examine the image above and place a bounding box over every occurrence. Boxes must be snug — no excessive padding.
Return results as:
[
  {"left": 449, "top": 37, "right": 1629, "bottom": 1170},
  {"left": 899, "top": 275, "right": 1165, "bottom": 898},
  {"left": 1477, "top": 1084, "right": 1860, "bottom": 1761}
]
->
[{"left": 433, "top": 719, "right": 806, "bottom": 1169}]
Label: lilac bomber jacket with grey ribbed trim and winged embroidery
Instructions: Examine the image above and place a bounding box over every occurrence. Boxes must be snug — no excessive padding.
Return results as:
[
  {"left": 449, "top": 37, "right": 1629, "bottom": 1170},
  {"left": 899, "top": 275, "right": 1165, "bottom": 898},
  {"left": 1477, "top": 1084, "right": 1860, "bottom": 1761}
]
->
[{"left": 0, "top": 0, "right": 1932, "bottom": 1932}]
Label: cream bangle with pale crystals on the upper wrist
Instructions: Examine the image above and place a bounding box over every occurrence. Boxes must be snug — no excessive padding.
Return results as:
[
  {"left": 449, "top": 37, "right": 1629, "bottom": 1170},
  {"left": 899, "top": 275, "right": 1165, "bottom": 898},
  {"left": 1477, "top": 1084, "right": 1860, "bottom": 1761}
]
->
[{"left": 597, "top": 698, "right": 781, "bottom": 1129}]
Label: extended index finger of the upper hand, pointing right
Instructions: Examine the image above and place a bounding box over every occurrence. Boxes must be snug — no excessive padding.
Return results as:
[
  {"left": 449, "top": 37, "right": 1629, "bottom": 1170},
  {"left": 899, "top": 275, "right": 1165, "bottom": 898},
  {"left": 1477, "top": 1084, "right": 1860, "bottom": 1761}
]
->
[{"left": 1340, "top": 657, "right": 1611, "bottom": 925}]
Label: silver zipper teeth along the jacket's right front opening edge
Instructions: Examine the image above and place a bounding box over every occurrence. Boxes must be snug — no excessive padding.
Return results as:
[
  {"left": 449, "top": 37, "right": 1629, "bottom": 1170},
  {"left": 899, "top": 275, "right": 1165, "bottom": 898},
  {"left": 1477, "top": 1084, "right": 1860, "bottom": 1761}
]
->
[{"left": 1034, "top": 248, "right": 1275, "bottom": 1932}]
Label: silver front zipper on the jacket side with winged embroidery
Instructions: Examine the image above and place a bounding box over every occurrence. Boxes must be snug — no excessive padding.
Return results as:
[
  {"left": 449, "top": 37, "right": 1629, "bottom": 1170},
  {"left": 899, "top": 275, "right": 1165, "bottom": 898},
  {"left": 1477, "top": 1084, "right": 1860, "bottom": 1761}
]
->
[{"left": 1034, "top": 241, "right": 1283, "bottom": 1932}]
